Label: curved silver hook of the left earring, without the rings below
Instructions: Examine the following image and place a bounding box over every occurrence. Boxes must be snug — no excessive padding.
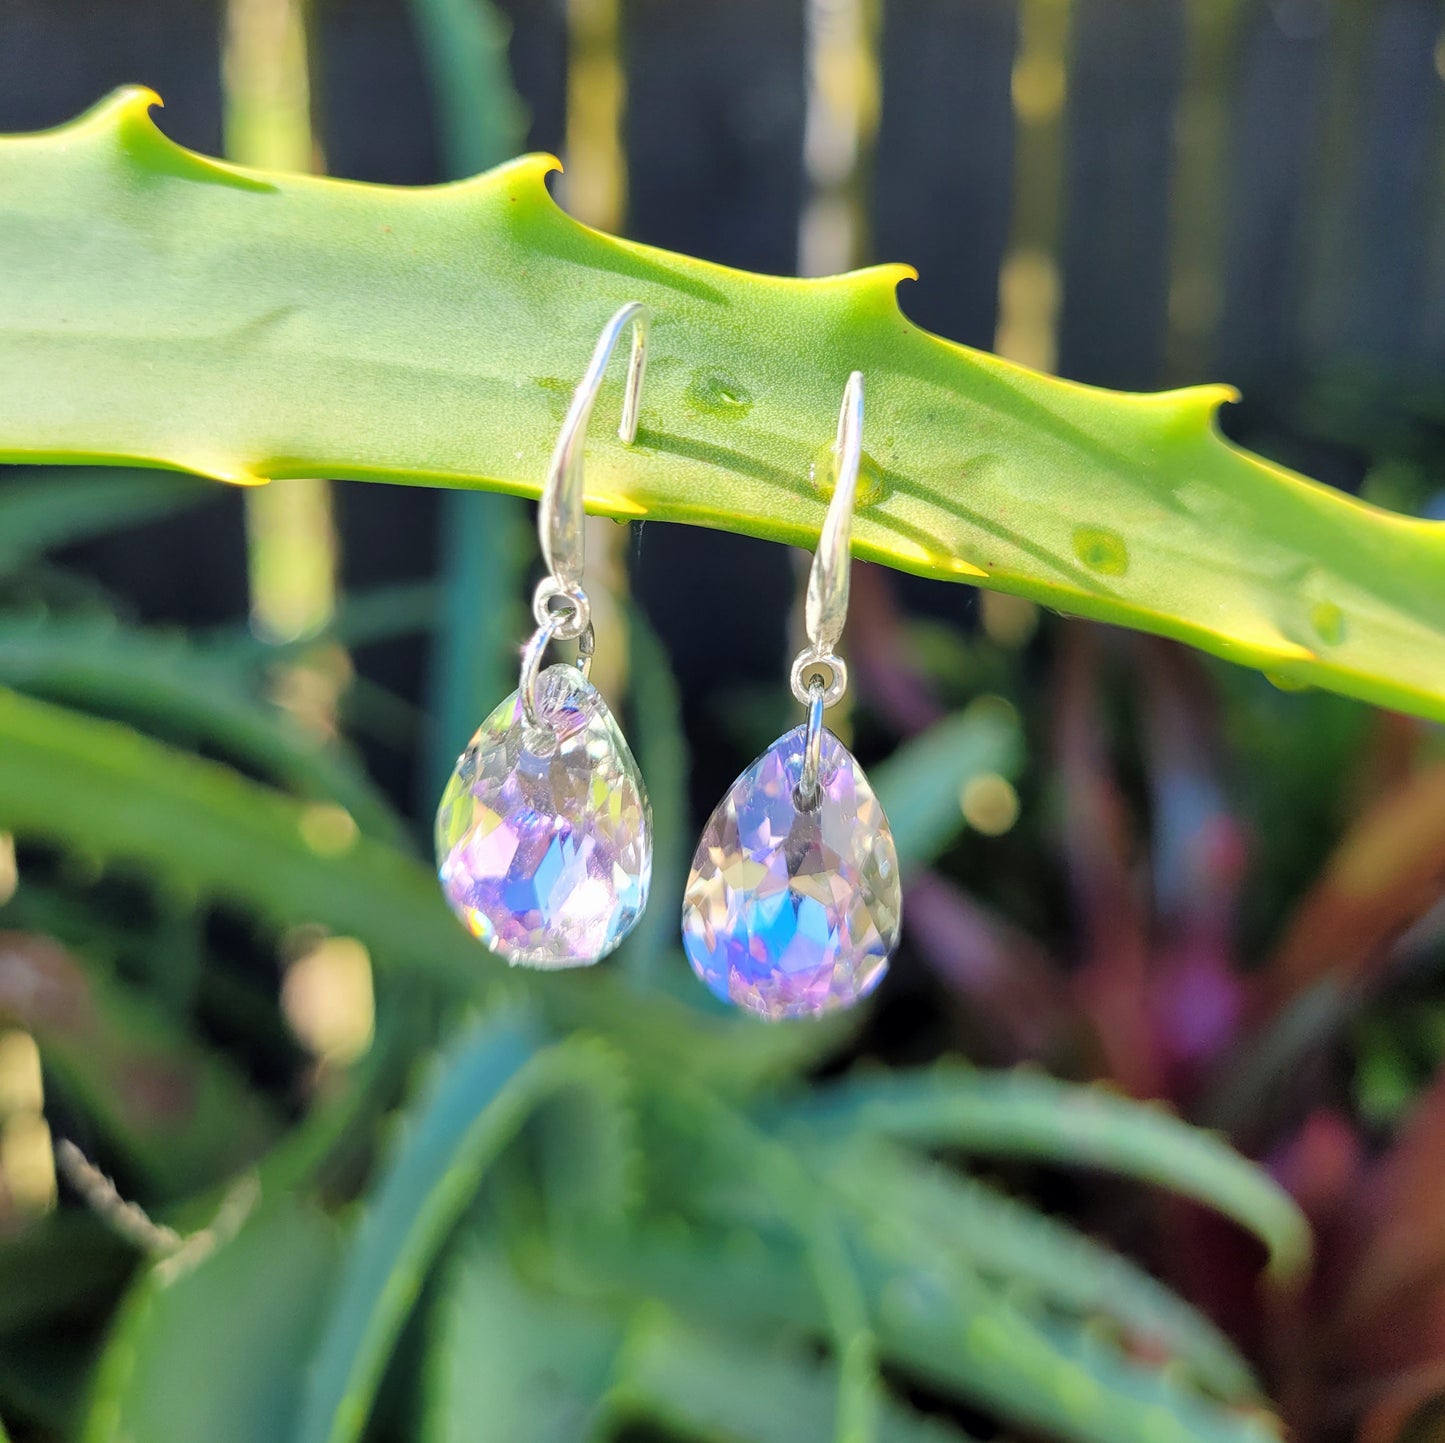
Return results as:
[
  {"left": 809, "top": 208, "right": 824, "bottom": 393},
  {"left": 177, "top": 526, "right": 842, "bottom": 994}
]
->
[{"left": 538, "top": 300, "right": 652, "bottom": 589}]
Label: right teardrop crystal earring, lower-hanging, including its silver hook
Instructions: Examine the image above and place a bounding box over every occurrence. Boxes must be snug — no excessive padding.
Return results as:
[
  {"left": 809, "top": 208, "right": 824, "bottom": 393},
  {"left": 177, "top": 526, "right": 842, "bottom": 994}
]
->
[{"left": 682, "top": 371, "right": 902, "bottom": 1020}]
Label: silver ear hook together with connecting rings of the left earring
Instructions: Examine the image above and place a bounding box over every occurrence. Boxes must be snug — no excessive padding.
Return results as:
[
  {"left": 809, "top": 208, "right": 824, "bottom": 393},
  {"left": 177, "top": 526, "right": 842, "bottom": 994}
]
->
[{"left": 520, "top": 300, "right": 652, "bottom": 727}]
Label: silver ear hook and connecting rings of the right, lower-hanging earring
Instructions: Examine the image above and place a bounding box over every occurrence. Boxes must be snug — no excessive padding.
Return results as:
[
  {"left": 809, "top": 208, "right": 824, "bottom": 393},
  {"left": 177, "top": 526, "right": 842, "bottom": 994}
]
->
[{"left": 792, "top": 371, "right": 863, "bottom": 806}]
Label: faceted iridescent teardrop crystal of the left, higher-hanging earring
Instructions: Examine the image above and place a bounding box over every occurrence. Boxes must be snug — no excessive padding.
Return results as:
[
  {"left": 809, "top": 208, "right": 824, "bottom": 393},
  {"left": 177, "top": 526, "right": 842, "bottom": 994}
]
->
[{"left": 436, "top": 666, "right": 652, "bottom": 968}]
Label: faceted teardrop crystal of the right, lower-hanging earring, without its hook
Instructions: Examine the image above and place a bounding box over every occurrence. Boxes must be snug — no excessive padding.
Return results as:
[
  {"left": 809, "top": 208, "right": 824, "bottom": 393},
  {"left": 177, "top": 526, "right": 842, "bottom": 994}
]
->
[{"left": 682, "top": 727, "right": 902, "bottom": 1018}]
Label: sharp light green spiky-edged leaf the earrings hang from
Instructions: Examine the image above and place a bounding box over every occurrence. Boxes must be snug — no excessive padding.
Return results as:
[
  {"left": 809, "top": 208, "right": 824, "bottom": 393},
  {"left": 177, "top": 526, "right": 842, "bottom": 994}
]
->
[{"left": 0, "top": 90, "right": 1445, "bottom": 718}]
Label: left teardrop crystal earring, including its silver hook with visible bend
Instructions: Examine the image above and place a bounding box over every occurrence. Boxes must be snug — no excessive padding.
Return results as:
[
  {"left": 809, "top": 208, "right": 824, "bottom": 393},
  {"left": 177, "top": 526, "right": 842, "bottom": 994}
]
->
[{"left": 436, "top": 302, "right": 652, "bottom": 968}]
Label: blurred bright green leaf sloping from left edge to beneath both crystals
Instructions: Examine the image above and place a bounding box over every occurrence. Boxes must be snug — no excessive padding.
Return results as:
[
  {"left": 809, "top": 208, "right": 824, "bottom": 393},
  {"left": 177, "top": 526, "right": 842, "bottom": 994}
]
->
[{"left": 0, "top": 688, "right": 845, "bottom": 1095}]
